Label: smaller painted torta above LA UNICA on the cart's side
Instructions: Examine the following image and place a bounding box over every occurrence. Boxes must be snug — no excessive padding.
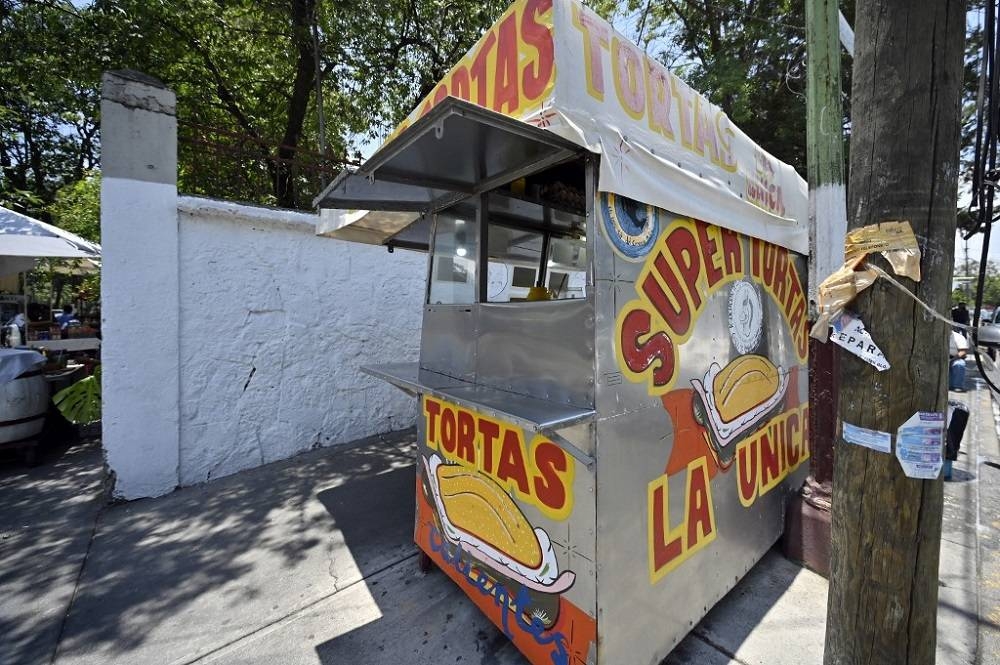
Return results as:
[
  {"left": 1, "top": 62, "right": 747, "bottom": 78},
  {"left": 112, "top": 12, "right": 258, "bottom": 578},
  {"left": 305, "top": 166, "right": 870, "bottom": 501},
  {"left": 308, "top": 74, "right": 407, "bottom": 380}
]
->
[{"left": 691, "top": 354, "right": 788, "bottom": 467}]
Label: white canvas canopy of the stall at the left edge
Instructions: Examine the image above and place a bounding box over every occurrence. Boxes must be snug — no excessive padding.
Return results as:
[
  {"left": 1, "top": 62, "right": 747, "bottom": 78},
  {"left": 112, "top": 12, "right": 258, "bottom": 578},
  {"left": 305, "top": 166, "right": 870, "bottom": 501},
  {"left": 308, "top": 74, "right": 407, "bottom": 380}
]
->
[{"left": 0, "top": 202, "right": 101, "bottom": 275}]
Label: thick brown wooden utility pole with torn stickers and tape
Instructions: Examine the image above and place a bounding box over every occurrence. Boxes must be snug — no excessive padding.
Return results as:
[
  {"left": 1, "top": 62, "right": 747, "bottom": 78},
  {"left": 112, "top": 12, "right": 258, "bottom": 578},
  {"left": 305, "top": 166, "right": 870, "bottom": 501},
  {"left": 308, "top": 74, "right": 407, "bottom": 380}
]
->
[{"left": 824, "top": 0, "right": 965, "bottom": 665}]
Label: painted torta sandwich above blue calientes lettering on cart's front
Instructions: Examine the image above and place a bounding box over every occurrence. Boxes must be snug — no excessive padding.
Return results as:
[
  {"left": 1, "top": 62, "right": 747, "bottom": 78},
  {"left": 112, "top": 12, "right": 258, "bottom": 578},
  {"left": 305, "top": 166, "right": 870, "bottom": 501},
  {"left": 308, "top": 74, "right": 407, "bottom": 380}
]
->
[{"left": 423, "top": 455, "right": 576, "bottom": 594}]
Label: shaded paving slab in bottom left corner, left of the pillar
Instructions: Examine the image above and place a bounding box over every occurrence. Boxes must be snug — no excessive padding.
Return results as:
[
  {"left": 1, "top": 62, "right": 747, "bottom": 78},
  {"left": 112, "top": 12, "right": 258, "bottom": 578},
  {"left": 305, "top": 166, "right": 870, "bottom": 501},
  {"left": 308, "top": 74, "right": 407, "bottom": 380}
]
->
[{"left": 0, "top": 441, "right": 104, "bottom": 664}]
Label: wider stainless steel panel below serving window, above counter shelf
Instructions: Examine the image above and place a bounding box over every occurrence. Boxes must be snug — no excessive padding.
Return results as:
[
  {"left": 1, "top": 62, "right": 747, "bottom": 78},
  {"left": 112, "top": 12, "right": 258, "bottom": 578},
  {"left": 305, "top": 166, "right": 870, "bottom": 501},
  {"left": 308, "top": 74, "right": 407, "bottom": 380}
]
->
[{"left": 476, "top": 297, "right": 594, "bottom": 409}]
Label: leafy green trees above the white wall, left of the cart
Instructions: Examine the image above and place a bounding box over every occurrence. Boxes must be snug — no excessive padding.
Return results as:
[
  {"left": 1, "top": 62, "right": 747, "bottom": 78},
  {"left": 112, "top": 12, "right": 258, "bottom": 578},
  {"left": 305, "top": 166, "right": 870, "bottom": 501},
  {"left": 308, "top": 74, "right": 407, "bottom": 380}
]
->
[{"left": 0, "top": 0, "right": 507, "bottom": 210}]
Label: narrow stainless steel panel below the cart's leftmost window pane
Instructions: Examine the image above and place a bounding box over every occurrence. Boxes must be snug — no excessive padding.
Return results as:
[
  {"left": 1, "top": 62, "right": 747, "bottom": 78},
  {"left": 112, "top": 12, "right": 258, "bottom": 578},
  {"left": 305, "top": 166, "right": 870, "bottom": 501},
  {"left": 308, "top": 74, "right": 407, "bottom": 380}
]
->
[{"left": 420, "top": 305, "right": 479, "bottom": 381}]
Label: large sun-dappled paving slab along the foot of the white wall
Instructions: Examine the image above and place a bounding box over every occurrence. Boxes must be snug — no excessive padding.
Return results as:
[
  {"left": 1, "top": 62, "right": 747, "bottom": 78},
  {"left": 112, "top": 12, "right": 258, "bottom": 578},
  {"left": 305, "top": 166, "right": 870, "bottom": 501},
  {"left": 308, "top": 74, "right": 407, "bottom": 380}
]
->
[{"left": 55, "top": 433, "right": 415, "bottom": 665}]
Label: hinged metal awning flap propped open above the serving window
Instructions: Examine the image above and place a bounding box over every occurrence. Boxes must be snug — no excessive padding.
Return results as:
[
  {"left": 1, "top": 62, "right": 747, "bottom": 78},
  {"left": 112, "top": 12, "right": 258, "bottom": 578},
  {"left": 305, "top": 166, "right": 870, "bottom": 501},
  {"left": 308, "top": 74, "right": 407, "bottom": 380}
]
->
[{"left": 314, "top": 97, "right": 583, "bottom": 212}]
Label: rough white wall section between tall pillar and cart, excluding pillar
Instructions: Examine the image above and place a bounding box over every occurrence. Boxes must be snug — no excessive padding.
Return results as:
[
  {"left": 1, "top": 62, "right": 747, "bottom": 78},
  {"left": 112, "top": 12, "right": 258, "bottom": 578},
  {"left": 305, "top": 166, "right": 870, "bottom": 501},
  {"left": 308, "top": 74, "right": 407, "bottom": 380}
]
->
[{"left": 178, "top": 198, "right": 426, "bottom": 485}]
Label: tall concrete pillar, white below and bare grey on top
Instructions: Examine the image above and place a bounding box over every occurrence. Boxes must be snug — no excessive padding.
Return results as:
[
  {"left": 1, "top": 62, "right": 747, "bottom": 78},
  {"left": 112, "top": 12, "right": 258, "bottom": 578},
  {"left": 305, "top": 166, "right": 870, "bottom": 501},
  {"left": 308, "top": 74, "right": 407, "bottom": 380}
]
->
[{"left": 101, "top": 71, "right": 180, "bottom": 499}]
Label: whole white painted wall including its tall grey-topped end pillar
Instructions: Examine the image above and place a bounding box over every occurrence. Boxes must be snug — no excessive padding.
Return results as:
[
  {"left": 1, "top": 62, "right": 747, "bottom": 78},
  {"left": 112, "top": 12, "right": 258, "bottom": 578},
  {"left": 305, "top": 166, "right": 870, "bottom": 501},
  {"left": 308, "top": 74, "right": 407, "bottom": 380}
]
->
[{"left": 101, "top": 71, "right": 426, "bottom": 499}]
